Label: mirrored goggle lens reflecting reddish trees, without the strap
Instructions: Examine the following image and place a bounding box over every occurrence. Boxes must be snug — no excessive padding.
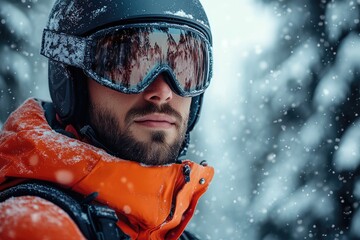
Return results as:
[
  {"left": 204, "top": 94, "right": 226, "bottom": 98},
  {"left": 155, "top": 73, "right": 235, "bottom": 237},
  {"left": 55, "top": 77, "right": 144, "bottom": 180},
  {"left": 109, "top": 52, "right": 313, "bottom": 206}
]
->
[{"left": 87, "top": 25, "right": 211, "bottom": 96}]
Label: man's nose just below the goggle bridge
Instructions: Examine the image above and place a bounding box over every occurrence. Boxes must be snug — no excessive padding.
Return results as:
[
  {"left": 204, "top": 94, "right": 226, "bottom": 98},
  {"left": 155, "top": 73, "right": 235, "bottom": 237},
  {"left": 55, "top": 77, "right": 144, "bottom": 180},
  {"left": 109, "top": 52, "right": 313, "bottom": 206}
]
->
[{"left": 144, "top": 74, "right": 174, "bottom": 105}]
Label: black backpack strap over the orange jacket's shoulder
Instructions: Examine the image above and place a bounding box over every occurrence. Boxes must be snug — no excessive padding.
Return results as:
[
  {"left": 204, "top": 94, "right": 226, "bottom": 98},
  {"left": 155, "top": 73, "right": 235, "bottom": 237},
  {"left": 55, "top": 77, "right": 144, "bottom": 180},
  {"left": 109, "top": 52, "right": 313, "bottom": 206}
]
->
[{"left": 0, "top": 181, "right": 130, "bottom": 240}]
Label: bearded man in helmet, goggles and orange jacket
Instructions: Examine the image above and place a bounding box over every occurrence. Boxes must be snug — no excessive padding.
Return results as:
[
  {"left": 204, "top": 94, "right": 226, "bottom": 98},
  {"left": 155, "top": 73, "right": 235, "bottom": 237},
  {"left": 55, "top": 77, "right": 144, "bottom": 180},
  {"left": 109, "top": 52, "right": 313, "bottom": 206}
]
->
[{"left": 0, "top": 0, "right": 213, "bottom": 239}]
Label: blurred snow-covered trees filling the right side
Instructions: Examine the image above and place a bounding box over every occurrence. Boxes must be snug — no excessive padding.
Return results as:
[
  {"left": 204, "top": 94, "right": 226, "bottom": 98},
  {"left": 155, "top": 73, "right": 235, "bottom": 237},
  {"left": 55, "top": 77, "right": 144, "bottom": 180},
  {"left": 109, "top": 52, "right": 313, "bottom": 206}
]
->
[{"left": 244, "top": 0, "right": 360, "bottom": 239}]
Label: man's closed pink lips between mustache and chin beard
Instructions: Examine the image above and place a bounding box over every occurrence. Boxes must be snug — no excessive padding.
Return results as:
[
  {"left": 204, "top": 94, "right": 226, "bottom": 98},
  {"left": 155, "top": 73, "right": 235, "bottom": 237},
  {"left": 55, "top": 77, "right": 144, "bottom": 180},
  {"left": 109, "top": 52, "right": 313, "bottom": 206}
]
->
[{"left": 134, "top": 113, "right": 176, "bottom": 128}]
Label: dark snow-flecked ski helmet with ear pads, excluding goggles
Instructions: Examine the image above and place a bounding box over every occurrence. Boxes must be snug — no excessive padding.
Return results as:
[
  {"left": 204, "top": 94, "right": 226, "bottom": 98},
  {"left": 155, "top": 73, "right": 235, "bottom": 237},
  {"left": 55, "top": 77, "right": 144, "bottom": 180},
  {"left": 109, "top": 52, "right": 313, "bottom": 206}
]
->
[{"left": 41, "top": 0, "right": 212, "bottom": 157}]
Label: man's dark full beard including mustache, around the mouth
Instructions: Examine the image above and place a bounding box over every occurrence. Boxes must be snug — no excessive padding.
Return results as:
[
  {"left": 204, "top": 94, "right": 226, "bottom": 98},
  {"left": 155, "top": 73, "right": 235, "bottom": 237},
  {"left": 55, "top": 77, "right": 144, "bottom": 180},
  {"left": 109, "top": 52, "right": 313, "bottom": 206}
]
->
[{"left": 89, "top": 103, "right": 188, "bottom": 165}]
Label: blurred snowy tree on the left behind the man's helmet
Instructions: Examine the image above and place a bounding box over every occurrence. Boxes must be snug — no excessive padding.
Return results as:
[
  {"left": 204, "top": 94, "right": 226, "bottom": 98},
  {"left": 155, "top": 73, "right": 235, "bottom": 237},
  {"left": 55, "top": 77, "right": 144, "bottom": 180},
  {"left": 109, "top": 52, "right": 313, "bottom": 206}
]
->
[{"left": 0, "top": 0, "right": 53, "bottom": 127}]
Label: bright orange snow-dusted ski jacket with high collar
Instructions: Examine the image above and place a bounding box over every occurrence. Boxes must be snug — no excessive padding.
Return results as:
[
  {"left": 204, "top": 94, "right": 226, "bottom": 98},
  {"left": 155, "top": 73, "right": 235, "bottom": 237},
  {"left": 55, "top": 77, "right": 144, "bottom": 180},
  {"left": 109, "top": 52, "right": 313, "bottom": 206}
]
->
[{"left": 0, "top": 99, "right": 214, "bottom": 239}]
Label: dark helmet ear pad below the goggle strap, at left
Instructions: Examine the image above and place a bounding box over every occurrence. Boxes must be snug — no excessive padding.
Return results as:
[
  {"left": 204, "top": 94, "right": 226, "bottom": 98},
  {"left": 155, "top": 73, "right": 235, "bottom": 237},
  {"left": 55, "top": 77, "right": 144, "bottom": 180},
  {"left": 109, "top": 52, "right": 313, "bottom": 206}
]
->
[{"left": 49, "top": 60, "right": 88, "bottom": 126}]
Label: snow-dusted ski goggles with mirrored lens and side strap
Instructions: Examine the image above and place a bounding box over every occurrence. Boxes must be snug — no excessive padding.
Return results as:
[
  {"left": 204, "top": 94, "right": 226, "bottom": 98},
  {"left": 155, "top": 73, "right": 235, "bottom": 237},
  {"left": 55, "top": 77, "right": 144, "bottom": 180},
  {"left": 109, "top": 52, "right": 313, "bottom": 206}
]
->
[{"left": 41, "top": 23, "right": 212, "bottom": 97}]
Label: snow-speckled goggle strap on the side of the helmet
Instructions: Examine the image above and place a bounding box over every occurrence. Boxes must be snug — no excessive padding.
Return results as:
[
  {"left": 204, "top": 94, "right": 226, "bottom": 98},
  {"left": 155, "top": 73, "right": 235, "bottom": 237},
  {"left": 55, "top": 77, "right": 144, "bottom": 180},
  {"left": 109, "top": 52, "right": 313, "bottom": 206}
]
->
[{"left": 40, "top": 29, "right": 87, "bottom": 69}]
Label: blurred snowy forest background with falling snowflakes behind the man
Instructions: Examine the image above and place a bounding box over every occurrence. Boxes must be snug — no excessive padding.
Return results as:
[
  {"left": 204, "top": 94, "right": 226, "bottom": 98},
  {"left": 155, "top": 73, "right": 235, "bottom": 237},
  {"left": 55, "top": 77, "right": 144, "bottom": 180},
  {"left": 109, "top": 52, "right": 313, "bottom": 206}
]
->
[{"left": 0, "top": 0, "right": 360, "bottom": 240}]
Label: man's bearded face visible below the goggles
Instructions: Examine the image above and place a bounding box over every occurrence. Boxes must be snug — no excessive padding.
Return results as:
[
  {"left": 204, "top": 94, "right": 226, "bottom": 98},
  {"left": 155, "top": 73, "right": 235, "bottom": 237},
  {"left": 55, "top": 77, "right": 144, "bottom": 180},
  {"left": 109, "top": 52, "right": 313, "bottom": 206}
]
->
[{"left": 88, "top": 75, "right": 191, "bottom": 165}]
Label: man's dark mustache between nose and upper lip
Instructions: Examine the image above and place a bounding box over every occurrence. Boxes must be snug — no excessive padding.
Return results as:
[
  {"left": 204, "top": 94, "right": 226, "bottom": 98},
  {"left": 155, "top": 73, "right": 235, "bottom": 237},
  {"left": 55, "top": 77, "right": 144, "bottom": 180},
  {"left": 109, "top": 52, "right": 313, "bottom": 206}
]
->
[{"left": 125, "top": 103, "right": 183, "bottom": 124}]
